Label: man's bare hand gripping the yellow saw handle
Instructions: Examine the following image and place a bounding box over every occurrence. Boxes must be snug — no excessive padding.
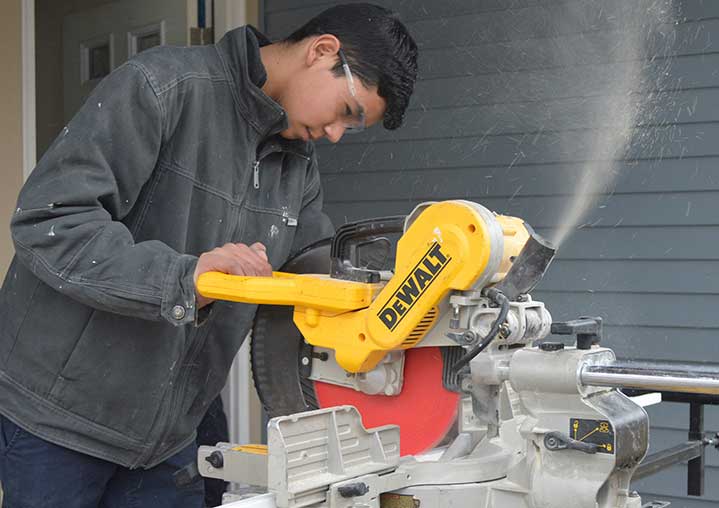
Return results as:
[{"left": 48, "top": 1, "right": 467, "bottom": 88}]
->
[{"left": 194, "top": 243, "right": 272, "bottom": 309}]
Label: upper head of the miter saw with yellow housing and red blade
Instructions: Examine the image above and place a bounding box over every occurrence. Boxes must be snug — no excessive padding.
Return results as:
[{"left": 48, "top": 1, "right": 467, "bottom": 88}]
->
[{"left": 199, "top": 201, "right": 551, "bottom": 454}]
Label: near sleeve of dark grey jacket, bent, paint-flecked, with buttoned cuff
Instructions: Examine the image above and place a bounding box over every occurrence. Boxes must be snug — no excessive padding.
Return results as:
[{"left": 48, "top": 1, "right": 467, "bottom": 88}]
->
[{"left": 11, "top": 62, "right": 197, "bottom": 325}]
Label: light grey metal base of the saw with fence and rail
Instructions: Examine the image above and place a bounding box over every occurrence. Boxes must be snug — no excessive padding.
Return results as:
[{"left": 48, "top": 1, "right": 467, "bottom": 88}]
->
[{"left": 198, "top": 318, "right": 719, "bottom": 508}]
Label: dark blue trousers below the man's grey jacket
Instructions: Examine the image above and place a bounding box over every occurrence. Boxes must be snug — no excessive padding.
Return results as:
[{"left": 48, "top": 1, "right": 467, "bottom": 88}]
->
[{"left": 0, "top": 415, "right": 204, "bottom": 508}]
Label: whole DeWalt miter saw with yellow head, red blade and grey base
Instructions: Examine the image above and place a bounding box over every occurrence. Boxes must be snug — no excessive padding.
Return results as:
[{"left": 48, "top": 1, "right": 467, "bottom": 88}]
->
[{"left": 198, "top": 201, "right": 719, "bottom": 508}]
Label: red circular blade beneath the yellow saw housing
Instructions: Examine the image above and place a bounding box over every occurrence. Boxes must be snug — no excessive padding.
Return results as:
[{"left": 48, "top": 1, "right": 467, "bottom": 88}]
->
[{"left": 314, "top": 347, "right": 459, "bottom": 456}]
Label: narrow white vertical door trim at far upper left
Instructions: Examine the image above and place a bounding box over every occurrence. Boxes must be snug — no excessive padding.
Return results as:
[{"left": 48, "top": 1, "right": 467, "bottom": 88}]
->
[{"left": 21, "top": 0, "right": 37, "bottom": 180}]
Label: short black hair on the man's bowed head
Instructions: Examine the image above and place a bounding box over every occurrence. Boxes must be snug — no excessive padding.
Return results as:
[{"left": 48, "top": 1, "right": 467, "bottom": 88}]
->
[{"left": 285, "top": 3, "right": 417, "bottom": 129}]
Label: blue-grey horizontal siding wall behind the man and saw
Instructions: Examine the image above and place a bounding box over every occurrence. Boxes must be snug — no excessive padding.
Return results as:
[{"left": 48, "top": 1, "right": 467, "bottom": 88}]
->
[{"left": 263, "top": 0, "right": 719, "bottom": 508}]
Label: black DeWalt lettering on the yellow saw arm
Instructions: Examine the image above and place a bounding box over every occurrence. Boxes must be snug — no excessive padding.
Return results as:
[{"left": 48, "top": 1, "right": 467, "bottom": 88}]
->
[{"left": 377, "top": 243, "right": 452, "bottom": 331}]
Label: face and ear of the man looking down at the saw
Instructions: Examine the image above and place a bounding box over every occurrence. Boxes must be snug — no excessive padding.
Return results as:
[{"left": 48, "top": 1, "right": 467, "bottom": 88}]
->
[{"left": 279, "top": 39, "right": 386, "bottom": 143}]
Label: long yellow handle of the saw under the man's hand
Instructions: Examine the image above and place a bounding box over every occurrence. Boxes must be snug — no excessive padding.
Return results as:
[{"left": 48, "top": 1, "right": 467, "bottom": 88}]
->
[{"left": 197, "top": 272, "right": 379, "bottom": 312}]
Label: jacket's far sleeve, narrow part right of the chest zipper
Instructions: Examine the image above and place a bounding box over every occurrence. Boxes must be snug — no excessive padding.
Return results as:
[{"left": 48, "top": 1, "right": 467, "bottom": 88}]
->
[{"left": 290, "top": 153, "right": 335, "bottom": 257}]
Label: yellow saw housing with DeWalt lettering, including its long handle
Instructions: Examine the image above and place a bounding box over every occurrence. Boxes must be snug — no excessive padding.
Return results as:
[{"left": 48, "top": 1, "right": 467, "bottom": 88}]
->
[{"left": 197, "top": 201, "right": 529, "bottom": 372}]
